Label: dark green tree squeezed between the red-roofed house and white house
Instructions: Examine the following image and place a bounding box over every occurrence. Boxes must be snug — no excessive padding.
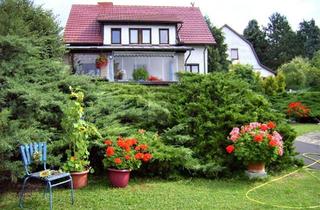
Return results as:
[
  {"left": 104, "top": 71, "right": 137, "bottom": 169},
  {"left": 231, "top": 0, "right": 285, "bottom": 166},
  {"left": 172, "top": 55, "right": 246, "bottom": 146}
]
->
[{"left": 204, "top": 16, "right": 230, "bottom": 72}]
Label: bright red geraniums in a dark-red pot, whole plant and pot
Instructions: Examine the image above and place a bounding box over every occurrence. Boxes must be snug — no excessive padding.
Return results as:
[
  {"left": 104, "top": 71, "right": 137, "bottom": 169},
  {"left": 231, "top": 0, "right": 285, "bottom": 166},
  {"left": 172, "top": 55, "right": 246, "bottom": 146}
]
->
[{"left": 104, "top": 130, "right": 152, "bottom": 187}]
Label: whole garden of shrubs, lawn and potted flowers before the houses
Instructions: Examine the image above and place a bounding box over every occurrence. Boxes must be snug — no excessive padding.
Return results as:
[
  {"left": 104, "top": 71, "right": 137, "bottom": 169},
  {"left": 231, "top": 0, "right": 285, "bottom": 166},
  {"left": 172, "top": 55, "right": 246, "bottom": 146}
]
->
[{"left": 0, "top": 0, "right": 320, "bottom": 209}]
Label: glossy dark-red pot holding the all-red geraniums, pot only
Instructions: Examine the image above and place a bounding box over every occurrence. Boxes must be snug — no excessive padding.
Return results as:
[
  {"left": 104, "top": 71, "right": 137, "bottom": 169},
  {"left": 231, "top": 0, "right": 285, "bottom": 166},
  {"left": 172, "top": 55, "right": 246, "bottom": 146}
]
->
[{"left": 108, "top": 168, "right": 130, "bottom": 187}]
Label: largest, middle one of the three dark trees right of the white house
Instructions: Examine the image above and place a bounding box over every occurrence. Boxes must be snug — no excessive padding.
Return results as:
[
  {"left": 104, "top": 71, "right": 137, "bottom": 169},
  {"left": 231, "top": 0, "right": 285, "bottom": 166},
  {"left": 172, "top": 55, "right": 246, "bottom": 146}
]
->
[{"left": 264, "top": 13, "right": 301, "bottom": 69}]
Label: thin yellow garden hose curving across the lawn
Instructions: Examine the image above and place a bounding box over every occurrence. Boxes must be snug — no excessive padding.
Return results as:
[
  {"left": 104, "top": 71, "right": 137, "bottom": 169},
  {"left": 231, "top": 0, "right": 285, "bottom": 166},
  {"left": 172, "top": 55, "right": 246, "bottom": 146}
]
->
[{"left": 246, "top": 153, "right": 320, "bottom": 209}]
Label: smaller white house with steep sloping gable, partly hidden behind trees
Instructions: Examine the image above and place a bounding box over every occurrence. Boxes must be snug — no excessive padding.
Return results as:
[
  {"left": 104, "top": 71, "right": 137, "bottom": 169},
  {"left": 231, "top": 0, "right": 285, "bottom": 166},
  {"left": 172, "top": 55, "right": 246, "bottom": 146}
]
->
[{"left": 221, "top": 25, "right": 275, "bottom": 77}]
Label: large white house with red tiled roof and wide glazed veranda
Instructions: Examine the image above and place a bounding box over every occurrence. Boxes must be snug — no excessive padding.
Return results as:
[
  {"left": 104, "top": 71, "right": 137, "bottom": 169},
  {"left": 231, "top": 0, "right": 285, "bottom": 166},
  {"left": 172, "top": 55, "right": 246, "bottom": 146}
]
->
[{"left": 64, "top": 2, "right": 215, "bottom": 81}]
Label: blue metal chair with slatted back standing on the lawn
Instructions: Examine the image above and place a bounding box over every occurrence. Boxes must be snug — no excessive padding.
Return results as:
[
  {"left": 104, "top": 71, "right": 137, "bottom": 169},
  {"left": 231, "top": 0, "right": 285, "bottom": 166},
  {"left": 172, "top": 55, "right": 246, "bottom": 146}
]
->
[{"left": 19, "top": 142, "right": 74, "bottom": 210}]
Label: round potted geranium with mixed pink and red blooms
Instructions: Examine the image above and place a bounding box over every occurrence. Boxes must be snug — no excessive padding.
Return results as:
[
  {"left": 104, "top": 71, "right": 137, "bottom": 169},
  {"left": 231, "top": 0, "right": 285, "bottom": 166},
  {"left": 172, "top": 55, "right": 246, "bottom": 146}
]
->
[{"left": 226, "top": 122, "right": 283, "bottom": 175}]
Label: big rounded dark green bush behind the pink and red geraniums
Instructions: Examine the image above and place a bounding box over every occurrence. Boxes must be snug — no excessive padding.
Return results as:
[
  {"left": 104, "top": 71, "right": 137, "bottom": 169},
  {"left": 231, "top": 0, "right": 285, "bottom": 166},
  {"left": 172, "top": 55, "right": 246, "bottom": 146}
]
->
[{"left": 163, "top": 73, "right": 294, "bottom": 177}]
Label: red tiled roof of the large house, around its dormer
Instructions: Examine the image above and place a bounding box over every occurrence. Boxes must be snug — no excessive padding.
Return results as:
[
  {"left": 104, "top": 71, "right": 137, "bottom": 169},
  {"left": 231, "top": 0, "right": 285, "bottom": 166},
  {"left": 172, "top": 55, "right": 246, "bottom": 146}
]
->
[{"left": 64, "top": 3, "right": 215, "bottom": 44}]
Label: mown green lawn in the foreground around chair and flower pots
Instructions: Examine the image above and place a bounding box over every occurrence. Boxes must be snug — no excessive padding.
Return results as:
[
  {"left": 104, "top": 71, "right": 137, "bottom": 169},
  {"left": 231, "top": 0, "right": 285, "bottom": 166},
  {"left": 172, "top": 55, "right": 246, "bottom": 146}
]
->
[{"left": 0, "top": 171, "right": 320, "bottom": 210}]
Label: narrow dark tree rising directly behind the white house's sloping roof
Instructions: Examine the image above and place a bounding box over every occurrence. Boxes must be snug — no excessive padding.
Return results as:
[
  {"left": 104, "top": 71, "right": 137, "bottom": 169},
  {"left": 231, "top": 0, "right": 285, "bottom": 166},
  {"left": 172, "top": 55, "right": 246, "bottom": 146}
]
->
[{"left": 243, "top": 19, "right": 268, "bottom": 64}]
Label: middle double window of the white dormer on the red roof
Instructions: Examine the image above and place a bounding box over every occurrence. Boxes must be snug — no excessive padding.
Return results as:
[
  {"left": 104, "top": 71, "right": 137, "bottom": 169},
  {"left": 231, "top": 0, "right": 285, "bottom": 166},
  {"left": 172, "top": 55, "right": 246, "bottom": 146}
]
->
[{"left": 129, "top": 28, "right": 151, "bottom": 44}]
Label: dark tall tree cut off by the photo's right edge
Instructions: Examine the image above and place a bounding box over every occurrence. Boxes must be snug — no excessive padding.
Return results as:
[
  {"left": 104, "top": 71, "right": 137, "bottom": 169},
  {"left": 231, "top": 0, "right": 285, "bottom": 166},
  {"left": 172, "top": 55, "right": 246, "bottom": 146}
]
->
[{"left": 297, "top": 19, "right": 320, "bottom": 59}]
